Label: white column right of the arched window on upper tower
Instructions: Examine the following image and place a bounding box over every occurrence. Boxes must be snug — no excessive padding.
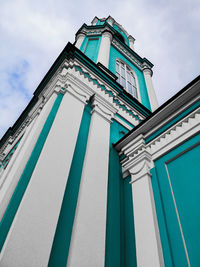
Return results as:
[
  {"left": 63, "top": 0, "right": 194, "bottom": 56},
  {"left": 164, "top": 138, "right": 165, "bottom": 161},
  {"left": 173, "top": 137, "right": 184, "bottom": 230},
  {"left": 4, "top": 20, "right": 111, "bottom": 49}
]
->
[{"left": 143, "top": 68, "right": 159, "bottom": 111}]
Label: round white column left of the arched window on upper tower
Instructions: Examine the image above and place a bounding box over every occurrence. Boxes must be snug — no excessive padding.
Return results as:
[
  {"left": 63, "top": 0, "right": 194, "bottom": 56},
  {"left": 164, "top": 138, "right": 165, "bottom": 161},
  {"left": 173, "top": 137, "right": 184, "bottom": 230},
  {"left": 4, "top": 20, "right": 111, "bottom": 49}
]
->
[{"left": 97, "top": 31, "right": 112, "bottom": 68}]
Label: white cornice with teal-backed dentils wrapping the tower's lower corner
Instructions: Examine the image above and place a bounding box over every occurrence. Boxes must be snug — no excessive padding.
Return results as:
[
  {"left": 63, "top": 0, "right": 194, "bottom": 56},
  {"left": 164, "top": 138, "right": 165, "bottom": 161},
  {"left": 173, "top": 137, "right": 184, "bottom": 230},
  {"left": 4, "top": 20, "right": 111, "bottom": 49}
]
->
[{"left": 0, "top": 56, "right": 147, "bottom": 164}]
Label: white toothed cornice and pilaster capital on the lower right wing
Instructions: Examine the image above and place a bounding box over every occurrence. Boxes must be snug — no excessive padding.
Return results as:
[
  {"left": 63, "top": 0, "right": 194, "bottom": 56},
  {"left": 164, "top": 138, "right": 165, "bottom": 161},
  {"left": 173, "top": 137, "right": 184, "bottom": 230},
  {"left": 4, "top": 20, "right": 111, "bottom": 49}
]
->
[{"left": 120, "top": 108, "right": 200, "bottom": 177}]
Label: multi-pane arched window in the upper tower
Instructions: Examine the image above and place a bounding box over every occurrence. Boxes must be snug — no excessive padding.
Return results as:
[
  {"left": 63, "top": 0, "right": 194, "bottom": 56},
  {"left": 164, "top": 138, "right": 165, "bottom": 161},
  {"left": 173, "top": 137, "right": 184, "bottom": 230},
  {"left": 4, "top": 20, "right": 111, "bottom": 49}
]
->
[{"left": 116, "top": 60, "right": 138, "bottom": 98}]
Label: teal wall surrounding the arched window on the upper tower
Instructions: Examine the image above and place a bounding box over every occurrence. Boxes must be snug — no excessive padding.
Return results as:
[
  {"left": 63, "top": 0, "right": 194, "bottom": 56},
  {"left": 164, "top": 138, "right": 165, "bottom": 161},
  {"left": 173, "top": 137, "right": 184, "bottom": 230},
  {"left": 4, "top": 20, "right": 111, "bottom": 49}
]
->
[{"left": 108, "top": 45, "right": 151, "bottom": 110}]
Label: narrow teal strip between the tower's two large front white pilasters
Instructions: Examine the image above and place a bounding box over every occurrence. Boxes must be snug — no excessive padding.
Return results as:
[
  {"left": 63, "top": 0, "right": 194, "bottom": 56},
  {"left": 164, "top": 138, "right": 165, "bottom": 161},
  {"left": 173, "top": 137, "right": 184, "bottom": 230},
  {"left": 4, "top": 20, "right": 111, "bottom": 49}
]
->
[{"left": 48, "top": 105, "right": 91, "bottom": 267}]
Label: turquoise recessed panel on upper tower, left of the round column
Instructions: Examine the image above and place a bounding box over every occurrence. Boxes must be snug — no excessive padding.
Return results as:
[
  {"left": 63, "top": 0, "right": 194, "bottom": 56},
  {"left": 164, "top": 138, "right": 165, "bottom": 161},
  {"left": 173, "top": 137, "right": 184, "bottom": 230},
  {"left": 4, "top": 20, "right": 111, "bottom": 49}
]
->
[{"left": 80, "top": 36, "right": 101, "bottom": 63}]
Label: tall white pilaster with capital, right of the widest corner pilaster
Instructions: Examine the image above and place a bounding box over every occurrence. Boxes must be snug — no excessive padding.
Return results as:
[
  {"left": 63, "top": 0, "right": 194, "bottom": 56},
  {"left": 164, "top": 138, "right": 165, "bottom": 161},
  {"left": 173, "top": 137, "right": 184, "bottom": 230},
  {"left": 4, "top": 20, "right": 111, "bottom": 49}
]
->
[{"left": 67, "top": 96, "right": 116, "bottom": 267}]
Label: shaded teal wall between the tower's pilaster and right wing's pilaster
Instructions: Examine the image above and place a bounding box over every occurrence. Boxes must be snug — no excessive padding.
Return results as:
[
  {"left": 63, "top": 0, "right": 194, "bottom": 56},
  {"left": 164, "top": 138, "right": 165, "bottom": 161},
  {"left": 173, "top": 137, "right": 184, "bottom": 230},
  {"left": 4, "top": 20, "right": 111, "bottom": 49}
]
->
[{"left": 105, "top": 120, "right": 136, "bottom": 267}]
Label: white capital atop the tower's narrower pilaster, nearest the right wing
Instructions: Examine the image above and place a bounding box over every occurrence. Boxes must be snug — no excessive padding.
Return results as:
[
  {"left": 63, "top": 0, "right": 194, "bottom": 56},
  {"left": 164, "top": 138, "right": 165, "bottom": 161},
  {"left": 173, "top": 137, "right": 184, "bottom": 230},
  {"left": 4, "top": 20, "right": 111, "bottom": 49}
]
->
[{"left": 91, "top": 95, "right": 117, "bottom": 123}]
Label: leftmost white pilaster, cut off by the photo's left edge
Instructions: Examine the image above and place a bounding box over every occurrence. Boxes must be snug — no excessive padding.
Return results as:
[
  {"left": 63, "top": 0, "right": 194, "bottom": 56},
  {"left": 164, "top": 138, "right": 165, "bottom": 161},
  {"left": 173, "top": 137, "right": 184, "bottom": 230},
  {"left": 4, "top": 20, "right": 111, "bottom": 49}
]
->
[{"left": 0, "top": 93, "right": 57, "bottom": 220}]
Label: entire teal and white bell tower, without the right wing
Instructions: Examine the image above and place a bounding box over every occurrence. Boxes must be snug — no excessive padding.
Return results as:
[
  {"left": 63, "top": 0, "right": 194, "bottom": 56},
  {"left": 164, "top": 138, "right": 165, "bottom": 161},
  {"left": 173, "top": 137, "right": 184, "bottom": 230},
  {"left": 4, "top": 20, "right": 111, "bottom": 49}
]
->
[{"left": 0, "top": 16, "right": 162, "bottom": 267}]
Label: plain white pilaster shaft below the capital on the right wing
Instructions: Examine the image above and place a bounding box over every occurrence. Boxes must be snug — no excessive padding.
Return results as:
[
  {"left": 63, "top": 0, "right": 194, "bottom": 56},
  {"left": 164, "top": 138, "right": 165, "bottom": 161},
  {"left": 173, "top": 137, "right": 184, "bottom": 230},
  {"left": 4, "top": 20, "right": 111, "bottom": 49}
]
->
[{"left": 132, "top": 173, "right": 164, "bottom": 267}]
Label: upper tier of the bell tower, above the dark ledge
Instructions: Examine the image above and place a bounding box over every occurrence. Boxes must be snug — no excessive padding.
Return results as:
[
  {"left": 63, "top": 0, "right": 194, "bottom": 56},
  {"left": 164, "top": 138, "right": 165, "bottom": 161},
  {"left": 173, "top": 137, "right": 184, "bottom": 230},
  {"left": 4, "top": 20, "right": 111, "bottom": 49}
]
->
[{"left": 76, "top": 16, "right": 158, "bottom": 111}]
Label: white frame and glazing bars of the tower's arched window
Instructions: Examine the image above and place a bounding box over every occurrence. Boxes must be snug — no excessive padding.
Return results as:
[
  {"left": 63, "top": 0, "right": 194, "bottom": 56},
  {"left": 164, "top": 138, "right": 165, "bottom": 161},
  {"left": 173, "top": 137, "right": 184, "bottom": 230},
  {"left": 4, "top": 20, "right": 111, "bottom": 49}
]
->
[{"left": 115, "top": 59, "right": 141, "bottom": 102}]
